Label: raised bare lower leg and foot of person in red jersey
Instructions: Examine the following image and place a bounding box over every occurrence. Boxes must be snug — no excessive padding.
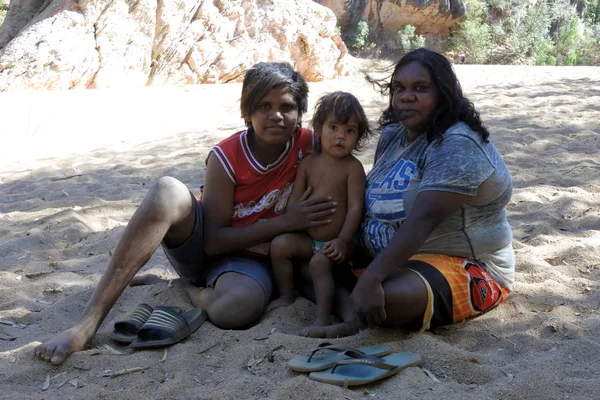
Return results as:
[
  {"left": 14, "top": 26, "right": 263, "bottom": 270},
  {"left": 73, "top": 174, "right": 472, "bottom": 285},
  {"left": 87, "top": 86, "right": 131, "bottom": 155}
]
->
[{"left": 34, "top": 177, "right": 195, "bottom": 364}]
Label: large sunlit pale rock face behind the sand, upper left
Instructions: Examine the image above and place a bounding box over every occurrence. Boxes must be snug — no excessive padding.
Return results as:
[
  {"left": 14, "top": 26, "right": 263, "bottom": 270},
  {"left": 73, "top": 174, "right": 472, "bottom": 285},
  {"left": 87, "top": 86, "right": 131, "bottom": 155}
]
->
[{"left": 0, "top": 0, "right": 354, "bottom": 91}]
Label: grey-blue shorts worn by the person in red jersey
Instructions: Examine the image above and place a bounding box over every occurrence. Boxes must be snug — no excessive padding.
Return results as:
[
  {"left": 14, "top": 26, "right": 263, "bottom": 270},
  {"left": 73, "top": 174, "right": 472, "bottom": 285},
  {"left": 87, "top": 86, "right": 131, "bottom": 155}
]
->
[{"left": 162, "top": 192, "right": 273, "bottom": 302}]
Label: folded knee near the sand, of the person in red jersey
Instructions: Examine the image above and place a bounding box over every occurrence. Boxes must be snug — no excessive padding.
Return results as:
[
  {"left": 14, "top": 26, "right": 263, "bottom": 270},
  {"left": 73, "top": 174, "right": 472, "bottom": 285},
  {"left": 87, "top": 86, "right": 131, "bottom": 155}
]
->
[{"left": 206, "top": 272, "right": 266, "bottom": 329}]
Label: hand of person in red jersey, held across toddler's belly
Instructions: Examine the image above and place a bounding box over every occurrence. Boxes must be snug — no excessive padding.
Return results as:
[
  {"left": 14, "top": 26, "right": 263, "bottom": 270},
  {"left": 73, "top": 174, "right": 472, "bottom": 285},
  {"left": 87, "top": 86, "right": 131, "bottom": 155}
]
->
[{"left": 284, "top": 187, "right": 337, "bottom": 232}]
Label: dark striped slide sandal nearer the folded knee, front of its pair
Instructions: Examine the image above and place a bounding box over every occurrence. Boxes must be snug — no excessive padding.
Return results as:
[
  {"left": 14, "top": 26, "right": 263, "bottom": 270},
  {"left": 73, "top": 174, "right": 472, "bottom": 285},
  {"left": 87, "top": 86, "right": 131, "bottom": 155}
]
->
[{"left": 129, "top": 306, "right": 207, "bottom": 349}]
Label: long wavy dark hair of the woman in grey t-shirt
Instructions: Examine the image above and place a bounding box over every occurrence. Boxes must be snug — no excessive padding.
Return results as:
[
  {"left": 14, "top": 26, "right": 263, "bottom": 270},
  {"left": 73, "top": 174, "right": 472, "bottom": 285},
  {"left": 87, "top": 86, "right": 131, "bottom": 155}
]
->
[{"left": 367, "top": 48, "right": 490, "bottom": 142}]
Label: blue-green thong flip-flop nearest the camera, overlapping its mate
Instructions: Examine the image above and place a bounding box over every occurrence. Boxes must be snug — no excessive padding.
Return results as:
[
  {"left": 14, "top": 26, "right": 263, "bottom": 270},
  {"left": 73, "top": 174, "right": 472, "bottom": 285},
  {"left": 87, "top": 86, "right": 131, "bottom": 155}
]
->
[{"left": 308, "top": 351, "right": 423, "bottom": 386}]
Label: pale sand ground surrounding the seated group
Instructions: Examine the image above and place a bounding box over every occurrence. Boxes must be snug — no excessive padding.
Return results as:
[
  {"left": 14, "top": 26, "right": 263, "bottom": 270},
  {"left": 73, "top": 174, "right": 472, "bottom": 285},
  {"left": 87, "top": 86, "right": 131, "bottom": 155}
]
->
[{"left": 0, "top": 66, "right": 600, "bottom": 399}]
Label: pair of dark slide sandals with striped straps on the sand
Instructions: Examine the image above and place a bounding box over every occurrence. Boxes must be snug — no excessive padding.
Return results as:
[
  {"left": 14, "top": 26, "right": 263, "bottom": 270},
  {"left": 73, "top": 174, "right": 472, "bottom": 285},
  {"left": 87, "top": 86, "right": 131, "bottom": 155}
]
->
[{"left": 110, "top": 303, "right": 207, "bottom": 349}]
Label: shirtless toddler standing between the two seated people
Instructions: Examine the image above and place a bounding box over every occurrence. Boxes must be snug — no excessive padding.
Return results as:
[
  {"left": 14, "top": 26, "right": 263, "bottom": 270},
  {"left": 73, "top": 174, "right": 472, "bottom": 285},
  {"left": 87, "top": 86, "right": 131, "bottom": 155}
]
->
[{"left": 267, "top": 92, "right": 371, "bottom": 335}]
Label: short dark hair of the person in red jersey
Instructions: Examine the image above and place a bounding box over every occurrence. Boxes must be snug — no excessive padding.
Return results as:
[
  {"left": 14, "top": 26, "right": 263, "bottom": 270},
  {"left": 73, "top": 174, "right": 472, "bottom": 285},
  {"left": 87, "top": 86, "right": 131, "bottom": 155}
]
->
[{"left": 240, "top": 62, "right": 308, "bottom": 127}]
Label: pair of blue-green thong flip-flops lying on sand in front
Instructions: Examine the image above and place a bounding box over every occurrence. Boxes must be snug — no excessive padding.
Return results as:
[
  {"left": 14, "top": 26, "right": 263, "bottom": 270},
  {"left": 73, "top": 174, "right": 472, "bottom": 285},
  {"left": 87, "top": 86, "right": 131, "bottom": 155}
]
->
[{"left": 288, "top": 343, "right": 423, "bottom": 386}]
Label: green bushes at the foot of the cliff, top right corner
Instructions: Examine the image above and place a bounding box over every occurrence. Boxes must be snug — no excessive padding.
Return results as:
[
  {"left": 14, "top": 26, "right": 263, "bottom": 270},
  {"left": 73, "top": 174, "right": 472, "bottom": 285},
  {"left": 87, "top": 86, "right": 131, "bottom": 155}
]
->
[{"left": 449, "top": 0, "right": 600, "bottom": 65}]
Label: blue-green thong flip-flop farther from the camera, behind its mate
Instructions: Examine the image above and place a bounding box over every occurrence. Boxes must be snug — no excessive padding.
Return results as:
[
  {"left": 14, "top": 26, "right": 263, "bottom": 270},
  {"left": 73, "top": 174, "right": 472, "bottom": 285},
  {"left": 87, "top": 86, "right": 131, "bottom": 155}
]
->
[{"left": 288, "top": 343, "right": 392, "bottom": 372}]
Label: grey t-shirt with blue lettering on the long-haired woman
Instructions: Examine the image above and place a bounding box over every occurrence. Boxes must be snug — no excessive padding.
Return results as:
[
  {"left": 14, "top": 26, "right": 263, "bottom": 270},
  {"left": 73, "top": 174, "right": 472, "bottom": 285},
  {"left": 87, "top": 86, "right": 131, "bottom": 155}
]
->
[{"left": 359, "top": 122, "right": 515, "bottom": 288}]
